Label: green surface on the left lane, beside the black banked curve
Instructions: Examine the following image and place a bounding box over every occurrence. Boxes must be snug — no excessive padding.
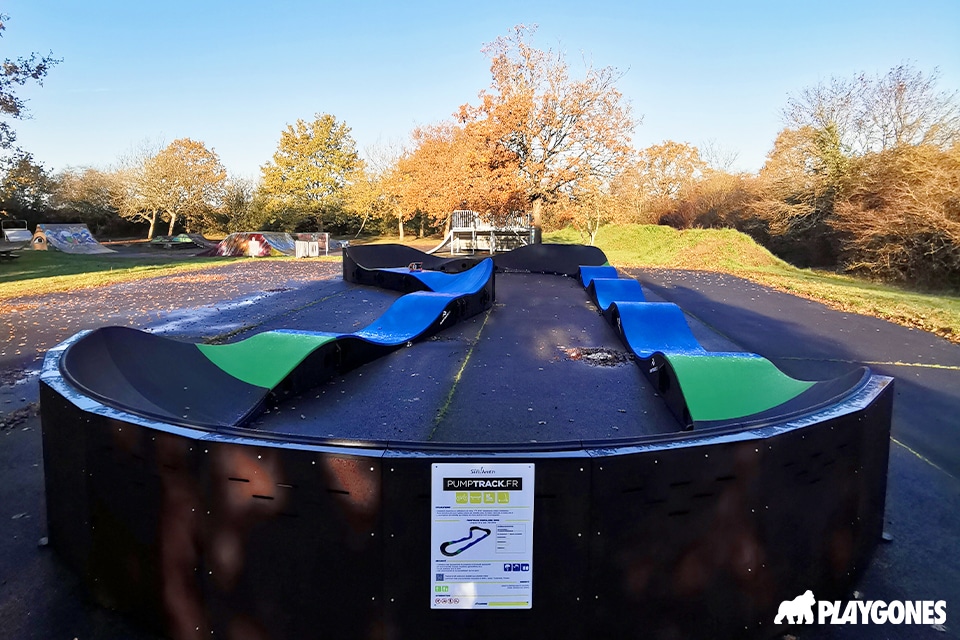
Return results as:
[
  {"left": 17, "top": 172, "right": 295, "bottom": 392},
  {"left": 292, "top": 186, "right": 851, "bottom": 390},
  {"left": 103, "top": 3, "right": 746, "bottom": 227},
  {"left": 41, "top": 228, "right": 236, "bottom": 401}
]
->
[{"left": 197, "top": 331, "right": 334, "bottom": 389}]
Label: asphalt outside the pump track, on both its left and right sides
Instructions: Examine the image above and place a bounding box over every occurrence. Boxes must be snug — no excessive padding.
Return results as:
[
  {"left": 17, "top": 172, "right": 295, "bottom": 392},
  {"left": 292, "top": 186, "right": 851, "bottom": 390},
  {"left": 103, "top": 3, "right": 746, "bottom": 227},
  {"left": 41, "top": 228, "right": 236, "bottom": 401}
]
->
[{"left": 0, "top": 260, "right": 960, "bottom": 640}]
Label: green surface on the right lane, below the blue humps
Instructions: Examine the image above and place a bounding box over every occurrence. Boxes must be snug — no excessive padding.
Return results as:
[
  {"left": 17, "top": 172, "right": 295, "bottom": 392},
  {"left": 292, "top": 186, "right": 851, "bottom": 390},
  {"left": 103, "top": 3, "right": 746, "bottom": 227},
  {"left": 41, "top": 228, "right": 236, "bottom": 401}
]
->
[{"left": 666, "top": 354, "right": 814, "bottom": 422}]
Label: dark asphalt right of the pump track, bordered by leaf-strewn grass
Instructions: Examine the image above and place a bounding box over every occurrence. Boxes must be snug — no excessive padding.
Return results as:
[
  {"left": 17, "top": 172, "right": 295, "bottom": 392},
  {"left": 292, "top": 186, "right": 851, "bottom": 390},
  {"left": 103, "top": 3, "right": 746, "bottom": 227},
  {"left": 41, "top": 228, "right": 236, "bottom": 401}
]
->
[{"left": 628, "top": 270, "right": 960, "bottom": 640}]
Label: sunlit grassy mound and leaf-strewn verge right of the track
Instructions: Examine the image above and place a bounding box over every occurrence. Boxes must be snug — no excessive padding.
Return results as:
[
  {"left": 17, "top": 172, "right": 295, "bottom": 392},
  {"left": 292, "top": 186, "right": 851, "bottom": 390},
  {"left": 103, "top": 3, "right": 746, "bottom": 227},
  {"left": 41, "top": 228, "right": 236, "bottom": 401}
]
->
[{"left": 544, "top": 225, "right": 960, "bottom": 343}]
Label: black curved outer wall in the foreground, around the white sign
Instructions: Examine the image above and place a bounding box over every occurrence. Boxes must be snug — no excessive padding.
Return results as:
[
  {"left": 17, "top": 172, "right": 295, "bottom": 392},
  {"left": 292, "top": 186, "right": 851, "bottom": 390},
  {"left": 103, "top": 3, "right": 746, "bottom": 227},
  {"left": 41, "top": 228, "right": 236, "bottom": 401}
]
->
[{"left": 41, "top": 376, "right": 892, "bottom": 638}]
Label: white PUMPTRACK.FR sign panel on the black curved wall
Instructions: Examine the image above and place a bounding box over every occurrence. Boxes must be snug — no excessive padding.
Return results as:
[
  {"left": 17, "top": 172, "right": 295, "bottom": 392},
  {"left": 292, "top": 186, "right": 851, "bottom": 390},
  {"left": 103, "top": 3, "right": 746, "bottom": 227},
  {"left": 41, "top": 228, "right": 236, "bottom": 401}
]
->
[{"left": 430, "top": 463, "right": 534, "bottom": 609}]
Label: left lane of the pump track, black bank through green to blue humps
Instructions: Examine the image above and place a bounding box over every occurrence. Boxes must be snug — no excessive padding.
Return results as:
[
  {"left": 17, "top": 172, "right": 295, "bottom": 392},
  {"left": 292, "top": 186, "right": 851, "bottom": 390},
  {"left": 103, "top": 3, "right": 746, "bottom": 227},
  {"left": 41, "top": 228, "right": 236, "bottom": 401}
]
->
[{"left": 60, "top": 259, "right": 493, "bottom": 428}]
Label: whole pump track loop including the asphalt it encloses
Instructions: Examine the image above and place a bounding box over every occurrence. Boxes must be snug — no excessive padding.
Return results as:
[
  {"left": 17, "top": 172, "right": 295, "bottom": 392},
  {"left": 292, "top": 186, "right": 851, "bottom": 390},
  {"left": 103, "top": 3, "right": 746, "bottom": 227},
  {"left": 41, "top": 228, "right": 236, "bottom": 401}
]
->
[{"left": 41, "top": 245, "right": 893, "bottom": 638}]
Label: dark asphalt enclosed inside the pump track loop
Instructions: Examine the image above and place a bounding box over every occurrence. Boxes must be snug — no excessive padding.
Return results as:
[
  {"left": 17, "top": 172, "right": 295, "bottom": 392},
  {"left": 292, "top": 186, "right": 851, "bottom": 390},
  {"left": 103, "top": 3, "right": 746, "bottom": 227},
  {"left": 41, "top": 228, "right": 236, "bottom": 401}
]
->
[{"left": 253, "top": 273, "right": 680, "bottom": 446}]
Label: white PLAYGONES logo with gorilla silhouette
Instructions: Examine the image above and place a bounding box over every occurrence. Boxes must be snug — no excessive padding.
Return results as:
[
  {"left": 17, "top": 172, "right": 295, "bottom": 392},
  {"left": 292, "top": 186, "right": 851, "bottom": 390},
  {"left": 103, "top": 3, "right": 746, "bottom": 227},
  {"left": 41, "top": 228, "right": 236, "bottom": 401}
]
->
[{"left": 773, "top": 590, "right": 947, "bottom": 625}]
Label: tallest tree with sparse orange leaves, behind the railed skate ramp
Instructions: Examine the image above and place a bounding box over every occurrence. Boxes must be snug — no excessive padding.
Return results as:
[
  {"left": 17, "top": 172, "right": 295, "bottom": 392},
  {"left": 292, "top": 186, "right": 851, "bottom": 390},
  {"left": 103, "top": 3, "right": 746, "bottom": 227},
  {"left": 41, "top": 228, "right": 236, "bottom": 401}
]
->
[{"left": 458, "top": 25, "right": 637, "bottom": 236}]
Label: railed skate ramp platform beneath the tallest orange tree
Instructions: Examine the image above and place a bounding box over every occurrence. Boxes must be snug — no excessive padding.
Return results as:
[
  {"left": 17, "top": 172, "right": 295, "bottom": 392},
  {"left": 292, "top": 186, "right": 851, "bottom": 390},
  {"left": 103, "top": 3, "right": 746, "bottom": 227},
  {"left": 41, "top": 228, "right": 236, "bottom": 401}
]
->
[{"left": 427, "top": 209, "right": 533, "bottom": 256}]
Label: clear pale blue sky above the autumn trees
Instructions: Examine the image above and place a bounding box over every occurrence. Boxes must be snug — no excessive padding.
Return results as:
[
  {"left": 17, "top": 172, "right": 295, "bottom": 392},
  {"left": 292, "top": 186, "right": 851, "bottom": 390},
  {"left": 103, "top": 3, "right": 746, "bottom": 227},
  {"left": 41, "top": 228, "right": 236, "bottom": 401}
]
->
[{"left": 0, "top": 0, "right": 960, "bottom": 178}]
